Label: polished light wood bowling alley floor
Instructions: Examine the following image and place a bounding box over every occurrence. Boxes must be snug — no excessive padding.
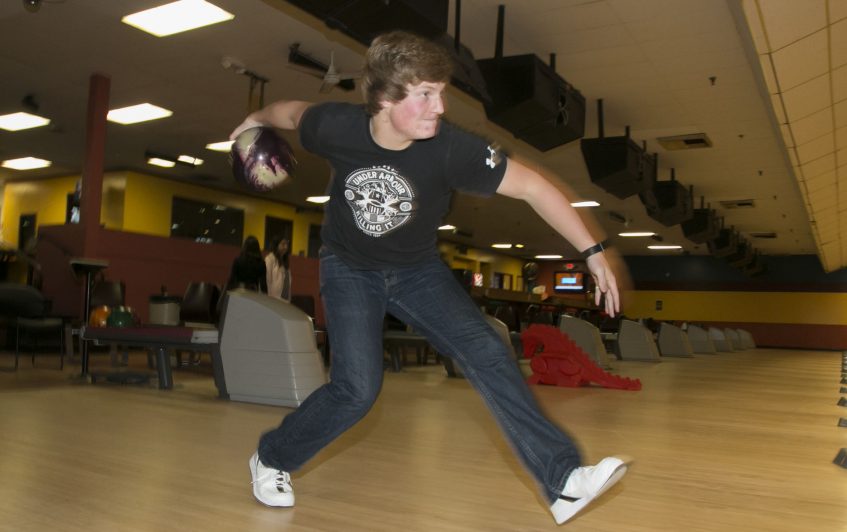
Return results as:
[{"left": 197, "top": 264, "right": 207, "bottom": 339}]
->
[{"left": 0, "top": 349, "right": 847, "bottom": 532}]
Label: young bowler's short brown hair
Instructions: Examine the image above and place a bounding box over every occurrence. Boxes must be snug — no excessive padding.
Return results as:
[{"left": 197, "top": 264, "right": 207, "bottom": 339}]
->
[{"left": 362, "top": 31, "right": 453, "bottom": 115}]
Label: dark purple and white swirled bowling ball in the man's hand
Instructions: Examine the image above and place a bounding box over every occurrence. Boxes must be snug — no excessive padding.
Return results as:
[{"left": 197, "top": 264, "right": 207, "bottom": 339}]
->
[{"left": 230, "top": 127, "right": 297, "bottom": 192}]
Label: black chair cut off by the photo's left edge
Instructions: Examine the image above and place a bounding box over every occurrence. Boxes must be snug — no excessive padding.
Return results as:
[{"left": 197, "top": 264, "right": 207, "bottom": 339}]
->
[{"left": 0, "top": 283, "right": 65, "bottom": 370}]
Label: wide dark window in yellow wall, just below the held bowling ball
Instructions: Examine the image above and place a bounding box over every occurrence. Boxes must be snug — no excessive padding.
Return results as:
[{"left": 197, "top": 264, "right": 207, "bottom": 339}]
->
[{"left": 171, "top": 196, "right": 244, "bottom": 247}]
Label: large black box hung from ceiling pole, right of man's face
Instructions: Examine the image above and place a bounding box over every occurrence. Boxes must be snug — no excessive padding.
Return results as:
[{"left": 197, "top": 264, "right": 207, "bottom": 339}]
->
[{"left": 477, "top": 5, "right": 585, "bottom": 151}]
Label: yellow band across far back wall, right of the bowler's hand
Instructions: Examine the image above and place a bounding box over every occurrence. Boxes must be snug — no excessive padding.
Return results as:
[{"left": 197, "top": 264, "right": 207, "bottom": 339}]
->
[{"left": 623, "top": 290, "right": 847, "bottom": 325}]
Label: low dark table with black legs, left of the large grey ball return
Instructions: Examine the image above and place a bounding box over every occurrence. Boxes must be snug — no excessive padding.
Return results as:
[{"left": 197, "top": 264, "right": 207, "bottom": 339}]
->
[{"left": 80, "top": 325, "right": 229, "bottom": 398}]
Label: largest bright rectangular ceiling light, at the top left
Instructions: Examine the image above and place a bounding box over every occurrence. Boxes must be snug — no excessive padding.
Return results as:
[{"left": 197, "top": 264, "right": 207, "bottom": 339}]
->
[{"left": 121, "top": 0, "right": 235, "bottom": 37}]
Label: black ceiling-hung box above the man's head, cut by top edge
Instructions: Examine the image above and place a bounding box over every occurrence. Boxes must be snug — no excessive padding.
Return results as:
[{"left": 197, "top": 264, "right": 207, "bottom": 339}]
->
[{"left": 288, "top": 0, "right": 450, "bottom": 45}]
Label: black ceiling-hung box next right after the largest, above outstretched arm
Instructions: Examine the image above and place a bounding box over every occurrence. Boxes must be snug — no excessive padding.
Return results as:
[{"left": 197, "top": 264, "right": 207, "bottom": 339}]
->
[{"left": 579, "top": 99, "right": 659, "bottom": 199}]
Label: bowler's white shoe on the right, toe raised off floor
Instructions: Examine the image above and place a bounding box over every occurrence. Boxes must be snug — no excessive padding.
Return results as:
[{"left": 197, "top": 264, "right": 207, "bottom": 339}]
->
[{"left": 550, "top": 456, "right": 631, "bottom": 525}]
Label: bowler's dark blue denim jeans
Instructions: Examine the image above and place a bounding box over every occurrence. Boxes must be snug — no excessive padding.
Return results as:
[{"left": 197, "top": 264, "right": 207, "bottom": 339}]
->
[{"left": 259, "top": 251, "right": 580, "bottom": 502}]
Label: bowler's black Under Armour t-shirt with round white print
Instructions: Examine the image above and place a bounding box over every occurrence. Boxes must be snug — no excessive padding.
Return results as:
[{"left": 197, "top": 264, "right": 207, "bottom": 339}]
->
[{"left": 300, "top": 103, "right": 506, "bottom": 269}]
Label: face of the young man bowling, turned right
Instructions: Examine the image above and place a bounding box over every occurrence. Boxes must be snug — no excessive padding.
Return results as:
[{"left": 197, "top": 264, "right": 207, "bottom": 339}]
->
[{"left": 385, "top": 81, "right": 446, "bottom": 140}]
